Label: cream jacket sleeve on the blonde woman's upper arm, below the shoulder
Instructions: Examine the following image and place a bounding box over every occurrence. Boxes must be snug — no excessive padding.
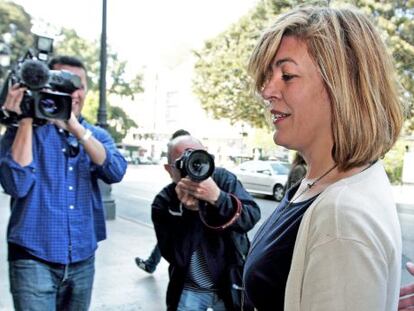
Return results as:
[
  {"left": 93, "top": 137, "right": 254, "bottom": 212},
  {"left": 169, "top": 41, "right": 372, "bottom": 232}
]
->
[{"left": 300, "top": 238, "right": 389, "bottom": 311}]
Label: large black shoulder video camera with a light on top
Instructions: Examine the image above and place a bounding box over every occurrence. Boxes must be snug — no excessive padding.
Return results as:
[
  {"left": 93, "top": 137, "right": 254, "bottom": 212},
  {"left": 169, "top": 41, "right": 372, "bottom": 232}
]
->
[{"left": 0, "top": 36, "right": 81, "bottom": 125}]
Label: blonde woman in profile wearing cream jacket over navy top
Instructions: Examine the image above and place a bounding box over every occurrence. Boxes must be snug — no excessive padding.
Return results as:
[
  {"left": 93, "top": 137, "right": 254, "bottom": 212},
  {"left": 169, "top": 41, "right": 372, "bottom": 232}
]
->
[{"left": 244, "top": 7, "right": 403, "bottom": 311}]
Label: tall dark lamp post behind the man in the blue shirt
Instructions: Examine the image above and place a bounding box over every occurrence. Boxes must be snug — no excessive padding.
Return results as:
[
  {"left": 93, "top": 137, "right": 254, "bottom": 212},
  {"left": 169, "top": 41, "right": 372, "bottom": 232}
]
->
[{"left": 97, "top": 0, "right": 116, "bottom": 220}]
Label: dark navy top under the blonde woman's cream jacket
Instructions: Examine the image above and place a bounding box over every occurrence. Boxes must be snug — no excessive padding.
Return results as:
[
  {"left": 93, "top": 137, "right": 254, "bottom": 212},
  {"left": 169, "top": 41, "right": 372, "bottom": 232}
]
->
[{"left": 243, "top": 187, "right": 316, "bottom": 311}]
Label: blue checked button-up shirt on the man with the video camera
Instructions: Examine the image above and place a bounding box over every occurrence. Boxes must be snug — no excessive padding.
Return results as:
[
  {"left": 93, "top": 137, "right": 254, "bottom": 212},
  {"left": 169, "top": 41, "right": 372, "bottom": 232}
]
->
[{"left": 0, "top": 118, "right": 127, "bottom": 264}]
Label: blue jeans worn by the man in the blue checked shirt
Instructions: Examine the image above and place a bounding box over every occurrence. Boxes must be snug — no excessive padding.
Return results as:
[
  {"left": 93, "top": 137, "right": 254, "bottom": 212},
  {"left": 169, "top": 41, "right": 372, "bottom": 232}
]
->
[{"left": 9, "top": 256, "right": 95, "bottom": 311}]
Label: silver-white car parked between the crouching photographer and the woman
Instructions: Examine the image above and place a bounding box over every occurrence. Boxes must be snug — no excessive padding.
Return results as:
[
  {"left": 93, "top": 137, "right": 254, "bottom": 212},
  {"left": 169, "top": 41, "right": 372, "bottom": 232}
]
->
[{"left": 233, "top": 160, "right": 290, "bottom": 202}]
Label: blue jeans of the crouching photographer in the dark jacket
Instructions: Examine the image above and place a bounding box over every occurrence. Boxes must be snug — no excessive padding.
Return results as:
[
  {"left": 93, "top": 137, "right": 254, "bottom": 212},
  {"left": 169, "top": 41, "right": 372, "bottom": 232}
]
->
[{"left": 177, "top": 289, "right": 226, "bottom": 311}]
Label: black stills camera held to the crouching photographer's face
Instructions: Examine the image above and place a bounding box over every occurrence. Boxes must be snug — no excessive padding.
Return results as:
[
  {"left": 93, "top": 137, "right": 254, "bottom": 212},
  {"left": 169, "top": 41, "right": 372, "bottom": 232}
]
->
[{"left": 175, "top": 149, "right": 215, "bottom": 182}]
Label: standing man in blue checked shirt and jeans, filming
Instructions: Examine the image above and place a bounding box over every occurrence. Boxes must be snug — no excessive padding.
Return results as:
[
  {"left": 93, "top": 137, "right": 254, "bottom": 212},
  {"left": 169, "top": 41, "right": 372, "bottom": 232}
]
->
[{"left": 0, "top": 56, "right": 127, "bottom": 311}]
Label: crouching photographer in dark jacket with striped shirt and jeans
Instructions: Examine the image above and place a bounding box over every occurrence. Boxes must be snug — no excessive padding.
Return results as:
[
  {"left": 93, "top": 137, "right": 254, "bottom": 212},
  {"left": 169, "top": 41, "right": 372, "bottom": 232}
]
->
[{"left": 152, "top": 135, "right": 260, "bottom": 311}]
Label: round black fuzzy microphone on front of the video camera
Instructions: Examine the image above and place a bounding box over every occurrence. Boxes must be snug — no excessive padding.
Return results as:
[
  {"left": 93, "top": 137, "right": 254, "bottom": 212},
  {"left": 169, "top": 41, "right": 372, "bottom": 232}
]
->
[{"left": 20, "top": 60, "right": 49, "bottom": 90}]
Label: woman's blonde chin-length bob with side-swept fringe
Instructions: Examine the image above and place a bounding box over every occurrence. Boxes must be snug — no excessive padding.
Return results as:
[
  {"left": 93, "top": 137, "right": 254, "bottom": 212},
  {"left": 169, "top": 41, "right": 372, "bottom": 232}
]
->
[{"left": 248, "top": 7, "right": 403, "bottom": 170}]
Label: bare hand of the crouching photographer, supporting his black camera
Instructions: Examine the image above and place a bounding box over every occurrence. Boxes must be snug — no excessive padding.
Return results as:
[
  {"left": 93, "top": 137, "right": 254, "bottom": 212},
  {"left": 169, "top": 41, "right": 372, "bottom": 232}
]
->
[{"left": 179, "top": 177, "right": 220, "bottom": 205}]
